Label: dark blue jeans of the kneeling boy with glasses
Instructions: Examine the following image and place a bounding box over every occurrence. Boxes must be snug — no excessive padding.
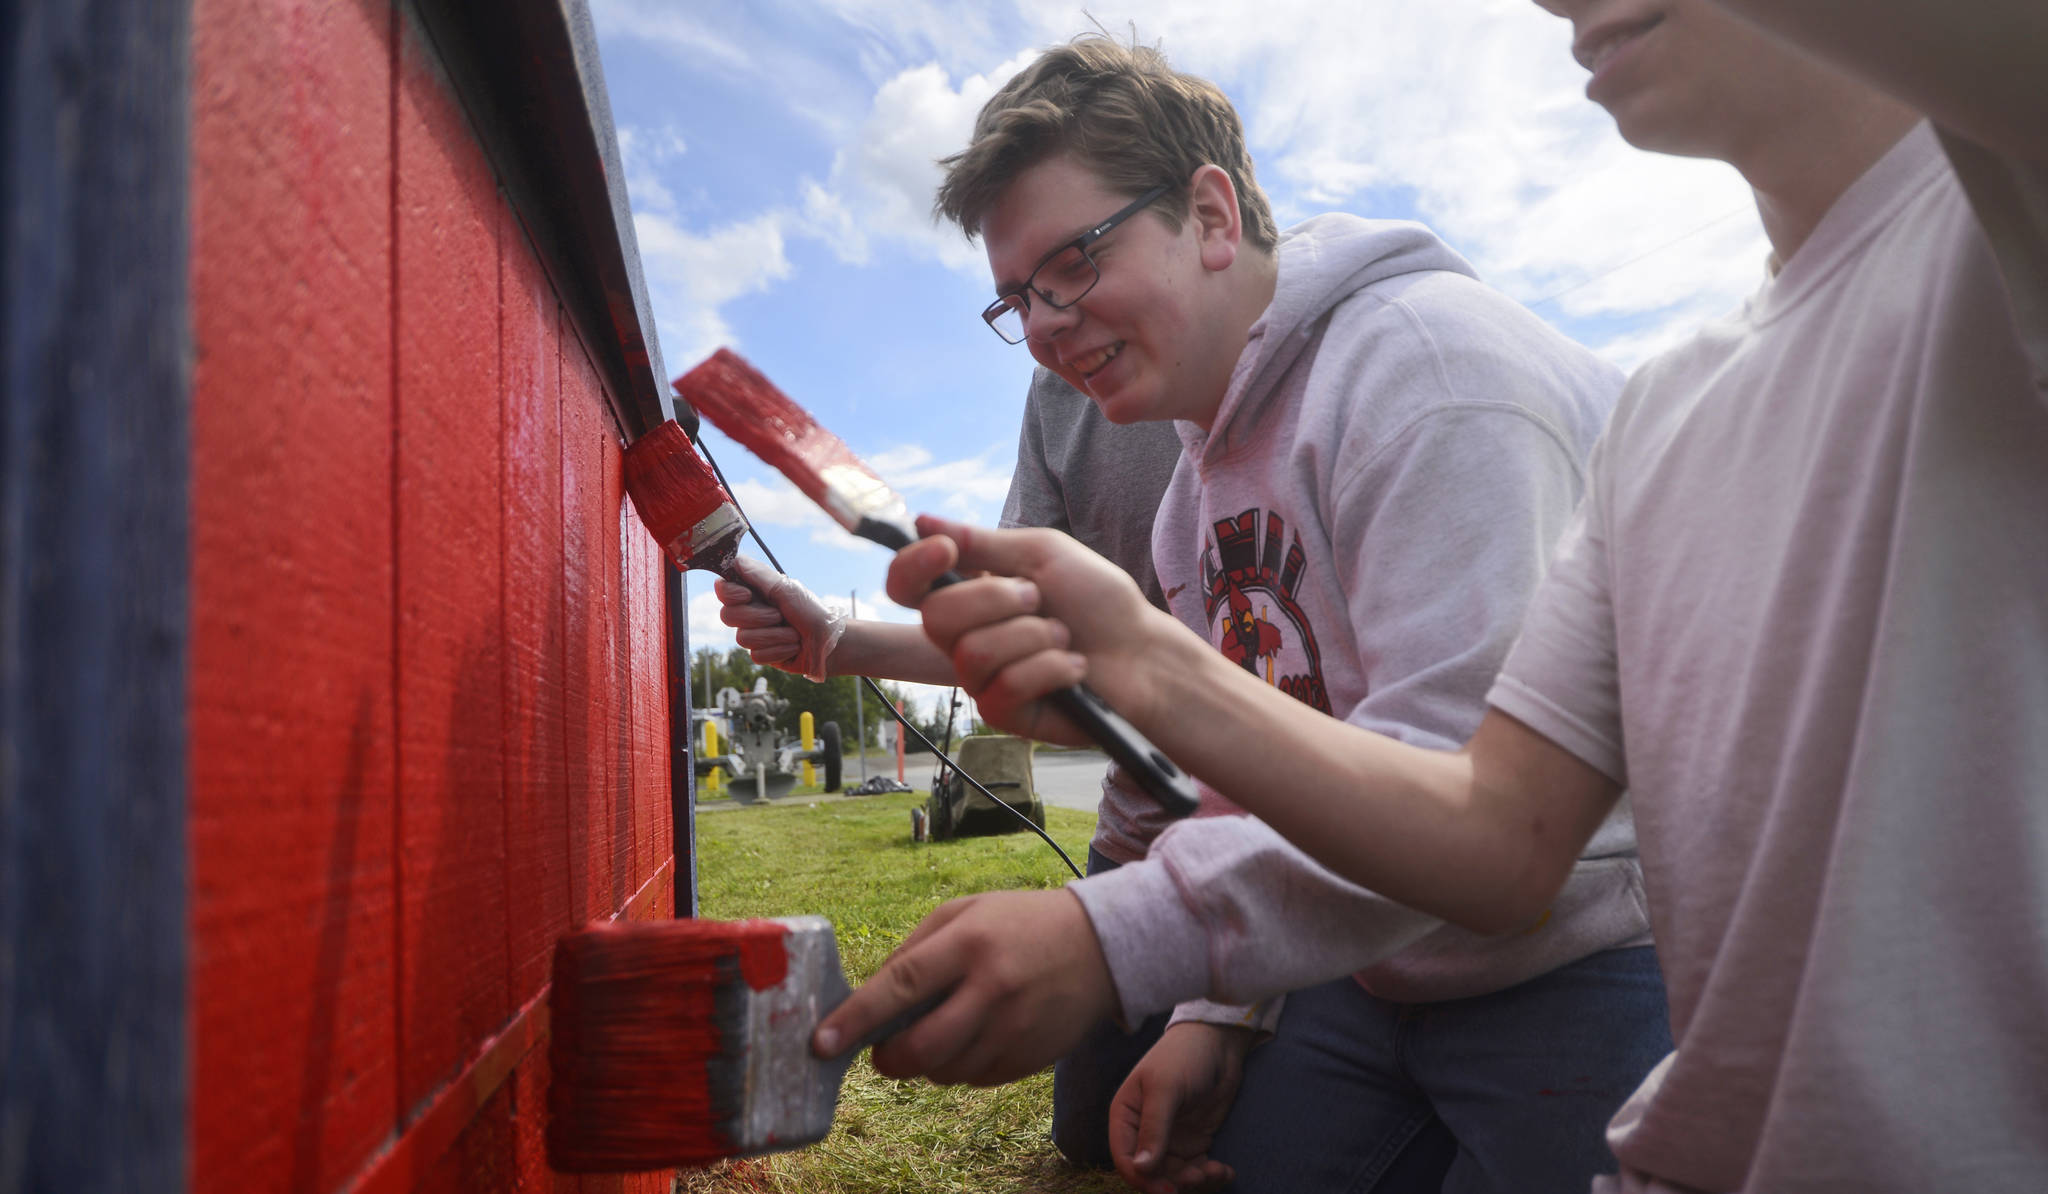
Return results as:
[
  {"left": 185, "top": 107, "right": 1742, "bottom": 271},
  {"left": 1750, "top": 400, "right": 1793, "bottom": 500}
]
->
[{"left": 1210, "top": 946, "right": 1671, "bottom": 1194}]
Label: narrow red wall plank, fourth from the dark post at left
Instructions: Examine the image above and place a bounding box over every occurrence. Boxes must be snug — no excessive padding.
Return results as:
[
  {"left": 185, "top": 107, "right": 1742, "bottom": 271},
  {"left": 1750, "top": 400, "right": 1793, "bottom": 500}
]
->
[{"left": 561, "top": 335, "right": 625, "bottom": 922}]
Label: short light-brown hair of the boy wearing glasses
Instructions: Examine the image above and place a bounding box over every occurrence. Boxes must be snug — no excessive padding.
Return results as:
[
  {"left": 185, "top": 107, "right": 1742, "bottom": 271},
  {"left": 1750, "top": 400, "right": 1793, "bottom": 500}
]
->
[{"left": 932, "top": 33, "right": 1280, "bottom": 252}]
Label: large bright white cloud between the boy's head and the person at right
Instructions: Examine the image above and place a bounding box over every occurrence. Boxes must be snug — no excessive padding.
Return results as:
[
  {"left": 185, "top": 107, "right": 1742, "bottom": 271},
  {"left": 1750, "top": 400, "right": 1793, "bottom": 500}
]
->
[{"left": 1011, "top": 0, "right": 1765, "bottom": 360}]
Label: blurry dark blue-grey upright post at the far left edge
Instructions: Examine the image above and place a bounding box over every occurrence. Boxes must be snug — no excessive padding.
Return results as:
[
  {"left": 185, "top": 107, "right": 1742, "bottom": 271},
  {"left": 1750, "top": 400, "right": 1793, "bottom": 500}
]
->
[{"left": 0, "top": 0, "right": 190, "bottom": 1192}]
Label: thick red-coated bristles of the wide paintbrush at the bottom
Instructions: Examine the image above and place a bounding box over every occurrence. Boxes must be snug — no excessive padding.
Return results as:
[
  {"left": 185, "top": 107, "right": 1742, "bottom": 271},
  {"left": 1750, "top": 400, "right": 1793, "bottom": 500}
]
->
[{"left": 547, "top": 920, "right": 788, "bottom": 1174}]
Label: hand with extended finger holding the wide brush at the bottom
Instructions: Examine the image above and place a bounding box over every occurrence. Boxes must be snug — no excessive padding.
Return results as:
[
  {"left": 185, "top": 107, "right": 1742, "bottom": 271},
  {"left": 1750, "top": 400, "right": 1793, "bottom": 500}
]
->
[{"left": 811, "top": 891, "right": 1116, "bottom": 1085}]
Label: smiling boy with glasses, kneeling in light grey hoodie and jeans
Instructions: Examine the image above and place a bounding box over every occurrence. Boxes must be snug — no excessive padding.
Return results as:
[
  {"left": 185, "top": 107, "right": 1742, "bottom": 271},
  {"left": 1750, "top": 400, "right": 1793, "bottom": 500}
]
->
[{"left": 790, "top": 37, "right": 1669, "bottom": 1192}]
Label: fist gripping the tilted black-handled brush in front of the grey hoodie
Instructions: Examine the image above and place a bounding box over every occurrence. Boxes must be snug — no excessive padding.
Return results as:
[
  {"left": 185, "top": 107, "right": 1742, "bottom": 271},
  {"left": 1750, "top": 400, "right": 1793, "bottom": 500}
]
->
[{"left": 889, "top": 516, "right": 1200, "bottom": 745}]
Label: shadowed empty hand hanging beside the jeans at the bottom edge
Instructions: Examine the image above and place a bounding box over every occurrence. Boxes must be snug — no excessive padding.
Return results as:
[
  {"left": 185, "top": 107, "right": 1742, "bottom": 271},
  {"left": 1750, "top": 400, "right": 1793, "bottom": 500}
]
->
[{"left": 1110, "top": 1020, "right": 1255, "bottom": 1194}]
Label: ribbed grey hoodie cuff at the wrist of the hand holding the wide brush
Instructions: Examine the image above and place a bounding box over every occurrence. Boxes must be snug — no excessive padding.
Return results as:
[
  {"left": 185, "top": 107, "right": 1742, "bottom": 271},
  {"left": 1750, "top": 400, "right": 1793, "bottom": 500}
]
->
[{"left": 1067, "top": 860, "right": 1208, "bottom": 1024}]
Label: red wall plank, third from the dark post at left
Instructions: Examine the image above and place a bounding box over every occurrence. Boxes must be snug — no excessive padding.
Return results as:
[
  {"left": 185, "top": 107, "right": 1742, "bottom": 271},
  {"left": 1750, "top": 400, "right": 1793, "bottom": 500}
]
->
[{"left": 500, "top": 207, "right": 569, "bottom": 999}]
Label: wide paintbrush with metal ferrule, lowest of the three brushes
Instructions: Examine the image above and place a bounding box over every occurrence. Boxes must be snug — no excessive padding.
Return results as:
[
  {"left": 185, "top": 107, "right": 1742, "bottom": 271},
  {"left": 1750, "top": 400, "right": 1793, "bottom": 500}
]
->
[{"left": 547, "top": 915, "right": 938, "bottom": 1174}]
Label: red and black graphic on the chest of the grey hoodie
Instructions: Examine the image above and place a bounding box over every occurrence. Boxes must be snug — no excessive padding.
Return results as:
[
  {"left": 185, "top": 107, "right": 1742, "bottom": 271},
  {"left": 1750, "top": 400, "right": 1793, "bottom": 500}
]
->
[{"left": 1202, "top": 508, "right": 1331, "bottom": 713}]
